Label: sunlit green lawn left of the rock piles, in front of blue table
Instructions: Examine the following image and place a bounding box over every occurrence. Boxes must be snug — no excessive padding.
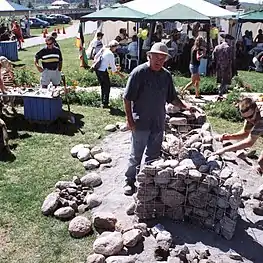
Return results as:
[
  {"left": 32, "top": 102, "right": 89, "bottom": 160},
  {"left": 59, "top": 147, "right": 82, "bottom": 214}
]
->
[{"left": 0, "top": 106, "right": 125, "bottom": 263}]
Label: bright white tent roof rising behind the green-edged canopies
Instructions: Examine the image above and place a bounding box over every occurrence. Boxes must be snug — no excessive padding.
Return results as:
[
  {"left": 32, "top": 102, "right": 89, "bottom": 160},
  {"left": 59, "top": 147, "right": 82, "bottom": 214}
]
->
[{"left": 124, "top": 0, "right": 236, "bottom": 17}]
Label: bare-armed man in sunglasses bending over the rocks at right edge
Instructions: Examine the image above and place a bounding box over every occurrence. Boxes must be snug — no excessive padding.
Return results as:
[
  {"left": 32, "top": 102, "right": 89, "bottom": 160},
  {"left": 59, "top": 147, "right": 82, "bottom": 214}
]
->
[{"left": 215, "top": 98, "right": 263, "bottom": 174}]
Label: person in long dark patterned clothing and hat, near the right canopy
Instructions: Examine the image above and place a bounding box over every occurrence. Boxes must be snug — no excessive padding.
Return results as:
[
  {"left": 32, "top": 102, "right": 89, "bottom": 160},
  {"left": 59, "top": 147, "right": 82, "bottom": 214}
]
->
[{"left": 212, "top": 34, "right": 234, "bottom": 100}]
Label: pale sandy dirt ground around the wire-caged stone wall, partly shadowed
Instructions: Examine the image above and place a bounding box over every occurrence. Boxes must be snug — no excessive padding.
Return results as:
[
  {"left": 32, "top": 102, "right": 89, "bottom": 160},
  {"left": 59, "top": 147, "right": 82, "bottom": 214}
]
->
[{"left": 93, "top": 132, "right": 263, "bottom": 263}]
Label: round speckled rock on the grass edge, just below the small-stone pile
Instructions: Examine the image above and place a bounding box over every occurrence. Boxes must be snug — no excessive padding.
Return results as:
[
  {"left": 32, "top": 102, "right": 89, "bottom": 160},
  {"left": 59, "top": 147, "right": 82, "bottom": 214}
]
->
[{"left": 68, "top": 216, "right": 92, "bottom": 237}]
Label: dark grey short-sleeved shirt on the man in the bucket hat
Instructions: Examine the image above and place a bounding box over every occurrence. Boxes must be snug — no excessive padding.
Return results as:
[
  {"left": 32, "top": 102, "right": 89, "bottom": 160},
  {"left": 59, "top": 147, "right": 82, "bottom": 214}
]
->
[{"left": 124, "top": 62, "right": 177, "bottom": 131}]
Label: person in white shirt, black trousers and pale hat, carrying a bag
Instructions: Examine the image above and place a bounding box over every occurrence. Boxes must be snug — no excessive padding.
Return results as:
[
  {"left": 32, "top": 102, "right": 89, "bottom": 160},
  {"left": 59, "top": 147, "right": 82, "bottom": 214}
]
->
[{"left": 95, "top": 40, "right": 124, "bottom": 108}]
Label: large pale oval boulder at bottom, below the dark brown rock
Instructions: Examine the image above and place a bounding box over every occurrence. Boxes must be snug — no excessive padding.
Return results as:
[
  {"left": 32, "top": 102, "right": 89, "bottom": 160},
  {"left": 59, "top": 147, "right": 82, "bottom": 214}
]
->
[{"left": 93, "top": 232, "right": 123, "bottom": 256}]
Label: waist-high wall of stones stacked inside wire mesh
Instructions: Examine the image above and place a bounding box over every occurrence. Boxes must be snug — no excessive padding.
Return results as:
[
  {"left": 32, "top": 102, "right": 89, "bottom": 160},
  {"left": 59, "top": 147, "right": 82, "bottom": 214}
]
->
[{"left": 135, "top": 124, "right": 243, "bottom": 239}]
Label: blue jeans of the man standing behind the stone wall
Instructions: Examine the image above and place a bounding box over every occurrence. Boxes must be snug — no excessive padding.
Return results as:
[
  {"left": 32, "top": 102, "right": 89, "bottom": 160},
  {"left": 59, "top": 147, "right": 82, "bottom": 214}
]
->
[{"left": 125, "top": 130, "right": 163, "bottom": 183}]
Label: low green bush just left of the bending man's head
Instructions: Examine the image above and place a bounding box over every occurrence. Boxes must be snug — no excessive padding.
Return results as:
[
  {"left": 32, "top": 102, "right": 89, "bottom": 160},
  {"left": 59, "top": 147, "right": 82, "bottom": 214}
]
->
[{"left": 204, "top": 90, "right": 243, "bottom": 122}]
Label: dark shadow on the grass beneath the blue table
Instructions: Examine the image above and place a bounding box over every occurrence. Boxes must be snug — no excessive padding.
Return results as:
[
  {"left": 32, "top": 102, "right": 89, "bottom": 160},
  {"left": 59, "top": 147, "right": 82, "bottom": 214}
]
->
[{"left": 2, "top": 111, "right": 84, "bottom": 139}]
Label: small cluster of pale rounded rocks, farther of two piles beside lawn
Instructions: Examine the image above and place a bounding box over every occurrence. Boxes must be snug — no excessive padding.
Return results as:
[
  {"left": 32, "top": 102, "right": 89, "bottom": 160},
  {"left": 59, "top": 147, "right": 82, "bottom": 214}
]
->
[{"left": 70, "top": 144, "right": 112, "bottom": 170}]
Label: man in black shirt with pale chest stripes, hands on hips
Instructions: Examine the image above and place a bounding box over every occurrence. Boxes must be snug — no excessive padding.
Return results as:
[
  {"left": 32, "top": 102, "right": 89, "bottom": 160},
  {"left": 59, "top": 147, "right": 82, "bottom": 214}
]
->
[{"left": 35, "top": 36, "right": 62, "bottom": 88}]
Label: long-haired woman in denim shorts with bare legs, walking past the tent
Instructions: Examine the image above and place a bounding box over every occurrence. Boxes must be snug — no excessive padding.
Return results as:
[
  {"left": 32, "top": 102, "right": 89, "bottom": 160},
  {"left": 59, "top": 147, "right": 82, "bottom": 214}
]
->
[{"left": 182, "top": 36, "right": 205, "bottom": 99}]
